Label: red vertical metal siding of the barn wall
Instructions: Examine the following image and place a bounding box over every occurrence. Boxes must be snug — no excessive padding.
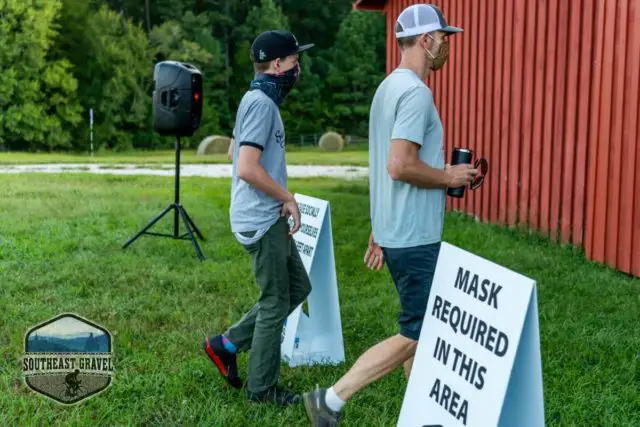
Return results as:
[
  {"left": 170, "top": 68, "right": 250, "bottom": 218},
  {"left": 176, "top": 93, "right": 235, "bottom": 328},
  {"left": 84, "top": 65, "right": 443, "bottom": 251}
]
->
[{"left": 385, "top": 0, "right": 640, "bottom": 276}]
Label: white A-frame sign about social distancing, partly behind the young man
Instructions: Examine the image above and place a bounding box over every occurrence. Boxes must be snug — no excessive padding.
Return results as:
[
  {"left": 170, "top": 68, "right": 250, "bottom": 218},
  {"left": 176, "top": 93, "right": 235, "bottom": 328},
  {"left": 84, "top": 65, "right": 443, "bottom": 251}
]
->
[{"left": 281, "top": 194, "right": 344, "bottom": 367}]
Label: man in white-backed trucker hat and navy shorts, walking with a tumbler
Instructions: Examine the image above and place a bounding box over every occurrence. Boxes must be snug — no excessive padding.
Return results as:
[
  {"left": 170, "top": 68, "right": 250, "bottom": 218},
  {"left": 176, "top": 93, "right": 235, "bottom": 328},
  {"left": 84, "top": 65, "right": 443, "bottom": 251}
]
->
[{"left": 304, "top": 4, "right": 477, "bottom": 427}]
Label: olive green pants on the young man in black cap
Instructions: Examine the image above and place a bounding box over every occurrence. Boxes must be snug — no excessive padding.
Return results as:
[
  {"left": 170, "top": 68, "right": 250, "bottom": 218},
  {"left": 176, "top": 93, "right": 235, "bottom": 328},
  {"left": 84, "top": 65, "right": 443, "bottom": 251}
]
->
[{"left": 224, "top": 218, "right": 311, "bottom": 393}]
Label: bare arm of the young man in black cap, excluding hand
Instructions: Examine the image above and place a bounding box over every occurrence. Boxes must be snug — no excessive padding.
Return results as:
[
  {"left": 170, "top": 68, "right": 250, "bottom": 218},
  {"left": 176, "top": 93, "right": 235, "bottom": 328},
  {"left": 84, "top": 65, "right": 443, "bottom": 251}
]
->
[{"left": 238, "top": 145, "right": 295, "bottom": 203}]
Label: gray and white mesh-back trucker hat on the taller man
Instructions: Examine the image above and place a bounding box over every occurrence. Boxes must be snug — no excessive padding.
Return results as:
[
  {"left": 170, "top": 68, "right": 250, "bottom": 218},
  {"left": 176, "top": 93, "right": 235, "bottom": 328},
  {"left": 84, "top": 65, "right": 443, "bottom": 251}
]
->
[{"left": 396, "top": 4, "right": 463, "bottom": 39}]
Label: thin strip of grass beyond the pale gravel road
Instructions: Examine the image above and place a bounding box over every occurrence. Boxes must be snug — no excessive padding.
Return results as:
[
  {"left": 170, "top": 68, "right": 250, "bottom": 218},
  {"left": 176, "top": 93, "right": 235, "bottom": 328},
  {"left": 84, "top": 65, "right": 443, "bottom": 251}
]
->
[{"left": 0, "top": 144, "right": 369, "bottom": 166}]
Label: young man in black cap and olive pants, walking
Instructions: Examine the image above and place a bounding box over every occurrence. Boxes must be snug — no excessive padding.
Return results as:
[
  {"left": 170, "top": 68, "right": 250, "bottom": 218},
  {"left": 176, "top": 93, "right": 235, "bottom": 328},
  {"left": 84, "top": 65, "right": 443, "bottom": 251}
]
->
[{"left": 203, "top": 30, "right": 313, "bottom": 406}]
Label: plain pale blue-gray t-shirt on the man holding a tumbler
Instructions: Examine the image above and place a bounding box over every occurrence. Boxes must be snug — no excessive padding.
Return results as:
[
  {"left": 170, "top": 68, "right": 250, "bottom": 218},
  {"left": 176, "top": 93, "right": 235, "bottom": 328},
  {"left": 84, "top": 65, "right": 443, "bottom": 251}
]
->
[{"left": 369, "top": 69, "right": 446, "bottom": 248}]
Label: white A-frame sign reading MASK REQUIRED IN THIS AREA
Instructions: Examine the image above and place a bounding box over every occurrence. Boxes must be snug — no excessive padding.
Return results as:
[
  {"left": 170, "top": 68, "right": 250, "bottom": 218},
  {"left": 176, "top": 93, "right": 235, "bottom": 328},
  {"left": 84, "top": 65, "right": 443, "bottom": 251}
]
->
[{"left": 398, "top": 242, "right": 544, "bottom": 427}]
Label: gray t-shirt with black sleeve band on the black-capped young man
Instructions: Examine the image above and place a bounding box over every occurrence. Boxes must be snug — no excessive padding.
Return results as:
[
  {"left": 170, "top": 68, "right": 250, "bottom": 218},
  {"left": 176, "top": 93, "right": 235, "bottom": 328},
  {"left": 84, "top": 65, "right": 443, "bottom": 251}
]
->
[{"left": 229, "top": 89, "right": 287, "bottom": 233}]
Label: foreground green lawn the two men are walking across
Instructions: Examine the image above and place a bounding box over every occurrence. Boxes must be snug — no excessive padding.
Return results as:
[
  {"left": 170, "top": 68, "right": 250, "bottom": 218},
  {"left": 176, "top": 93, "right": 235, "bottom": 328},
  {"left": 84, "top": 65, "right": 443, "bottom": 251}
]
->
[{"left": 0, "top": 174, "right": 640, "bottom": 427}]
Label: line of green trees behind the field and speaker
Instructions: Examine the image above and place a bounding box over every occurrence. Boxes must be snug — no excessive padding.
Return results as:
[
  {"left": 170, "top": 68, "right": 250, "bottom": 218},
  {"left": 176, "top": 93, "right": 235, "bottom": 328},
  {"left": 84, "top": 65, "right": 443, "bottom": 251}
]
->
[{"left": 0, "top": 0, "right": 386, "bottom": 151}]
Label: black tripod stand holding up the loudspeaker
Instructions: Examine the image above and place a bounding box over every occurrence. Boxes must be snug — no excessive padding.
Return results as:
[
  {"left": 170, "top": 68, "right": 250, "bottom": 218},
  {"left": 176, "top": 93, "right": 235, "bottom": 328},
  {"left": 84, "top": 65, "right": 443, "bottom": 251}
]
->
[{"left": 122, "top": 136, "right": 204, "bottom": 261}]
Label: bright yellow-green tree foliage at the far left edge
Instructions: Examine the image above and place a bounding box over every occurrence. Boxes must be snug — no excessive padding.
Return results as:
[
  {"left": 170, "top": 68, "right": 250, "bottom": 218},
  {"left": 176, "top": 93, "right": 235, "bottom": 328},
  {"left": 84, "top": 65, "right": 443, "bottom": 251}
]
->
[{"left": 0, "top": 0, "right": 81, "bottom": 150}]
